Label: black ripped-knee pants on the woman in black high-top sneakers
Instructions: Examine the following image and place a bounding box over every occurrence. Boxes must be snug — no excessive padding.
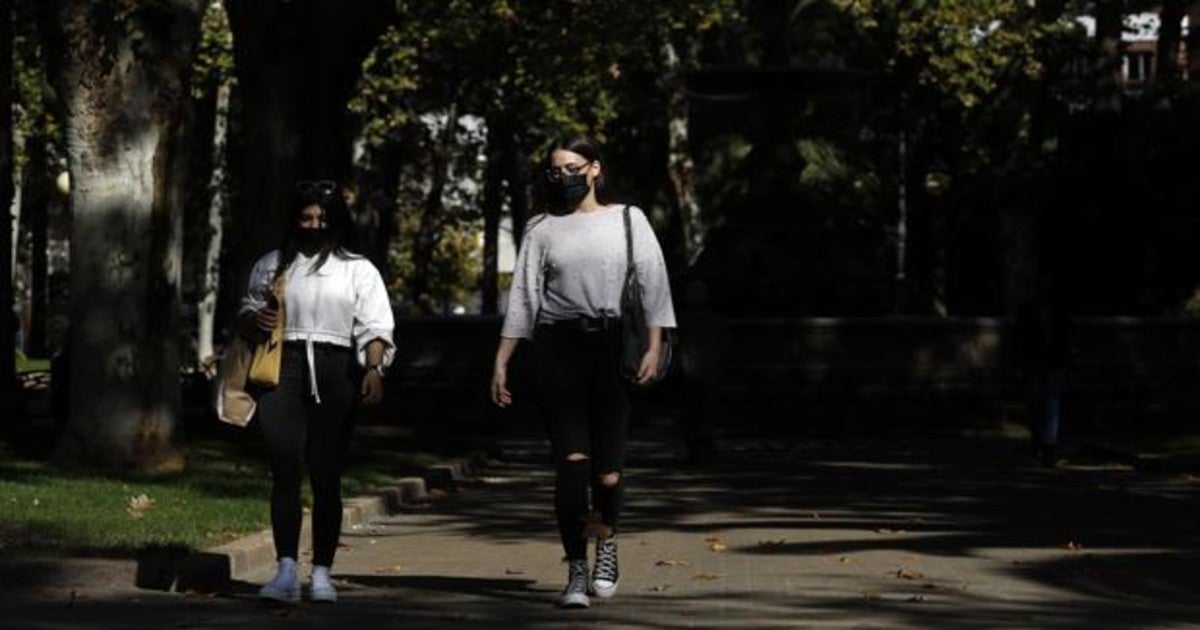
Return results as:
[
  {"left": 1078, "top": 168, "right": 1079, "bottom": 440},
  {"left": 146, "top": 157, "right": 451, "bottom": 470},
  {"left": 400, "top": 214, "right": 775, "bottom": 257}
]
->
[{"left": 533, "top": 324, "right": 629, "bottom": 559}]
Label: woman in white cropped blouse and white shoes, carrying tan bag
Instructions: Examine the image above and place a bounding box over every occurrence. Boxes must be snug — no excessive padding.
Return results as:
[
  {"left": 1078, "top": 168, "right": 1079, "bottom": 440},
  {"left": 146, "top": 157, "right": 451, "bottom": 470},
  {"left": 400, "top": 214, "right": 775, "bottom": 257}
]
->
[{"left": 239, "top": 180, "right": 395, "bottom": 601}]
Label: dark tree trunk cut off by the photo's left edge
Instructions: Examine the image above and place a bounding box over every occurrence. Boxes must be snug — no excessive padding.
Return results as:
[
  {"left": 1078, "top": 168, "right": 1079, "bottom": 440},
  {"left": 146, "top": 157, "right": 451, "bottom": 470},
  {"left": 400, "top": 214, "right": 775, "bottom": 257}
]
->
[{"left": 0, "top": 0, "right": 17, "bottom": 422}]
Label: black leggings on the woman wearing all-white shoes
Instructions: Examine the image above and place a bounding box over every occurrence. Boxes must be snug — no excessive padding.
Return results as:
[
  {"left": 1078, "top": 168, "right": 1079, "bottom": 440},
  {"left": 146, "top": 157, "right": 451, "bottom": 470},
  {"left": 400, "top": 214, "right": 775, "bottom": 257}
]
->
[{"left": 258, "top": 342, "right": 356, "bottom": 566}]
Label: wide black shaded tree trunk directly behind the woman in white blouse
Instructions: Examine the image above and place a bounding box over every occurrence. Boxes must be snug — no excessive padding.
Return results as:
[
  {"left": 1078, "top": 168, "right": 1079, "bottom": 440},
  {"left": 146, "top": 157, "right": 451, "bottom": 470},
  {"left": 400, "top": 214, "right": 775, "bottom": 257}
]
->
[{"left": 222, "top": 0, "right": 395, "bottom": 328}]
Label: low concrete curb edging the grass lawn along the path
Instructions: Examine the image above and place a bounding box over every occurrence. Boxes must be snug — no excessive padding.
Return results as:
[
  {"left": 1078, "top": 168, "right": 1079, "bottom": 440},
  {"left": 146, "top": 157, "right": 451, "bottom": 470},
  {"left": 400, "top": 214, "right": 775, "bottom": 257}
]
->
[{"left": 165, "top": 451, "right": 488, "bottom": 592}]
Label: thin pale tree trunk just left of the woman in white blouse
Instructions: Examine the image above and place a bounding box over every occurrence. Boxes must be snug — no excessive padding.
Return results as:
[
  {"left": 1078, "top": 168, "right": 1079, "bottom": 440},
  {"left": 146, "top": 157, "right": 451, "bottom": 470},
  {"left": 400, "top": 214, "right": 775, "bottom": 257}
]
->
[{"left": 196, "top": 80, "right": 233, "bottom": 371}]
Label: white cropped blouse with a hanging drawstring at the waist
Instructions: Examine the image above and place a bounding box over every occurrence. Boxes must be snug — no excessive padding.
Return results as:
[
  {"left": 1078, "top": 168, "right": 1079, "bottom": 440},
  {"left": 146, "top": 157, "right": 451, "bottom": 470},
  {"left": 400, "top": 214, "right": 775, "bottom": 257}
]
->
[{"left": 240, "top": 250, "right": 396, "bottom": 402}]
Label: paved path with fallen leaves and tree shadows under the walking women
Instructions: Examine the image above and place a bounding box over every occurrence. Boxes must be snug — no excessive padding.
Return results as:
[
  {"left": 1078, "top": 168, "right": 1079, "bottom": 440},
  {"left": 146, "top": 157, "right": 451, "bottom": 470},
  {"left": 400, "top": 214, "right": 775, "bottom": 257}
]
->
[{"left": 0, "top": 440, "right": 1200, "bottom": 629}]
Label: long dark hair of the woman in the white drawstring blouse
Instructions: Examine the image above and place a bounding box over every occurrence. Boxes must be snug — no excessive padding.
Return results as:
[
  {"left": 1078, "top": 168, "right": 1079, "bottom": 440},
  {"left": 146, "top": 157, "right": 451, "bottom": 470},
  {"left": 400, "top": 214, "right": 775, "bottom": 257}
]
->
[{"left": 275, "top": 180, "right": 358, "bottom": 276}]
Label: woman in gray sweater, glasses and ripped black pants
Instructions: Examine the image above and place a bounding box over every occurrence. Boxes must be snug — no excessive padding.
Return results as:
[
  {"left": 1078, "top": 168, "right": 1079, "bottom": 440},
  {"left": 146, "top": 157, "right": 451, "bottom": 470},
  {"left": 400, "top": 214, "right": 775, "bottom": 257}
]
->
[{"left": 491, "top": 137, "right": 676, "bottom": 607}]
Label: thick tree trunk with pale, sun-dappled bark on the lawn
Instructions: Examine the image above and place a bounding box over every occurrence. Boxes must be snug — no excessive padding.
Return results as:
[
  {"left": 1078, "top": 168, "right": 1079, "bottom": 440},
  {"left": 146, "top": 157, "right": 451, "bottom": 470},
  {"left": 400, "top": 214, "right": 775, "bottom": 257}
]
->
[{"left": 40, "top": 0, "right": 205, "bottom": 472}]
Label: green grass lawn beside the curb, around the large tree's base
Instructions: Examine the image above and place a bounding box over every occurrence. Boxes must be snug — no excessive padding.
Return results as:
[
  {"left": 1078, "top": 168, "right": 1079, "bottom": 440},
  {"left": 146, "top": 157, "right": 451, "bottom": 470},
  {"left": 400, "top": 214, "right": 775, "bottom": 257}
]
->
[{"left": 0, "top": 427, "right": 443, "bottom": 557}]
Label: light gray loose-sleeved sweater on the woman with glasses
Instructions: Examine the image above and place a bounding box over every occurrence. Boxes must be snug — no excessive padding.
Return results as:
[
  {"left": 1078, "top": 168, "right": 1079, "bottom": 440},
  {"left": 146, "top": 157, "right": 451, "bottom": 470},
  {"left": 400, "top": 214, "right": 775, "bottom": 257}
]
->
[{"left": 500, "top": 205, "right": 676, "bottom": 338}]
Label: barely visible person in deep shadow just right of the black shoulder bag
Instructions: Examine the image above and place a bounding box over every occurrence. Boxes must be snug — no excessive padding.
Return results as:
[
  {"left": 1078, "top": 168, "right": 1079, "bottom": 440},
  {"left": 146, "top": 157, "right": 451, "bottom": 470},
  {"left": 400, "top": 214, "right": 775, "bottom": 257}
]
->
[{"left": 679, "top": 278, "right": 730, "bottom": 466}]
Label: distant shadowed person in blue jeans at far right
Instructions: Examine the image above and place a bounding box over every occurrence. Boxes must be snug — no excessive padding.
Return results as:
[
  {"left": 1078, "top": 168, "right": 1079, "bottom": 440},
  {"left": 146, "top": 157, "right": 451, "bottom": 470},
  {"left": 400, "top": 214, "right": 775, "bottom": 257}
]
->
[{"left": 1015, "top": 277, "right": 1075, "bottom": 467}]
